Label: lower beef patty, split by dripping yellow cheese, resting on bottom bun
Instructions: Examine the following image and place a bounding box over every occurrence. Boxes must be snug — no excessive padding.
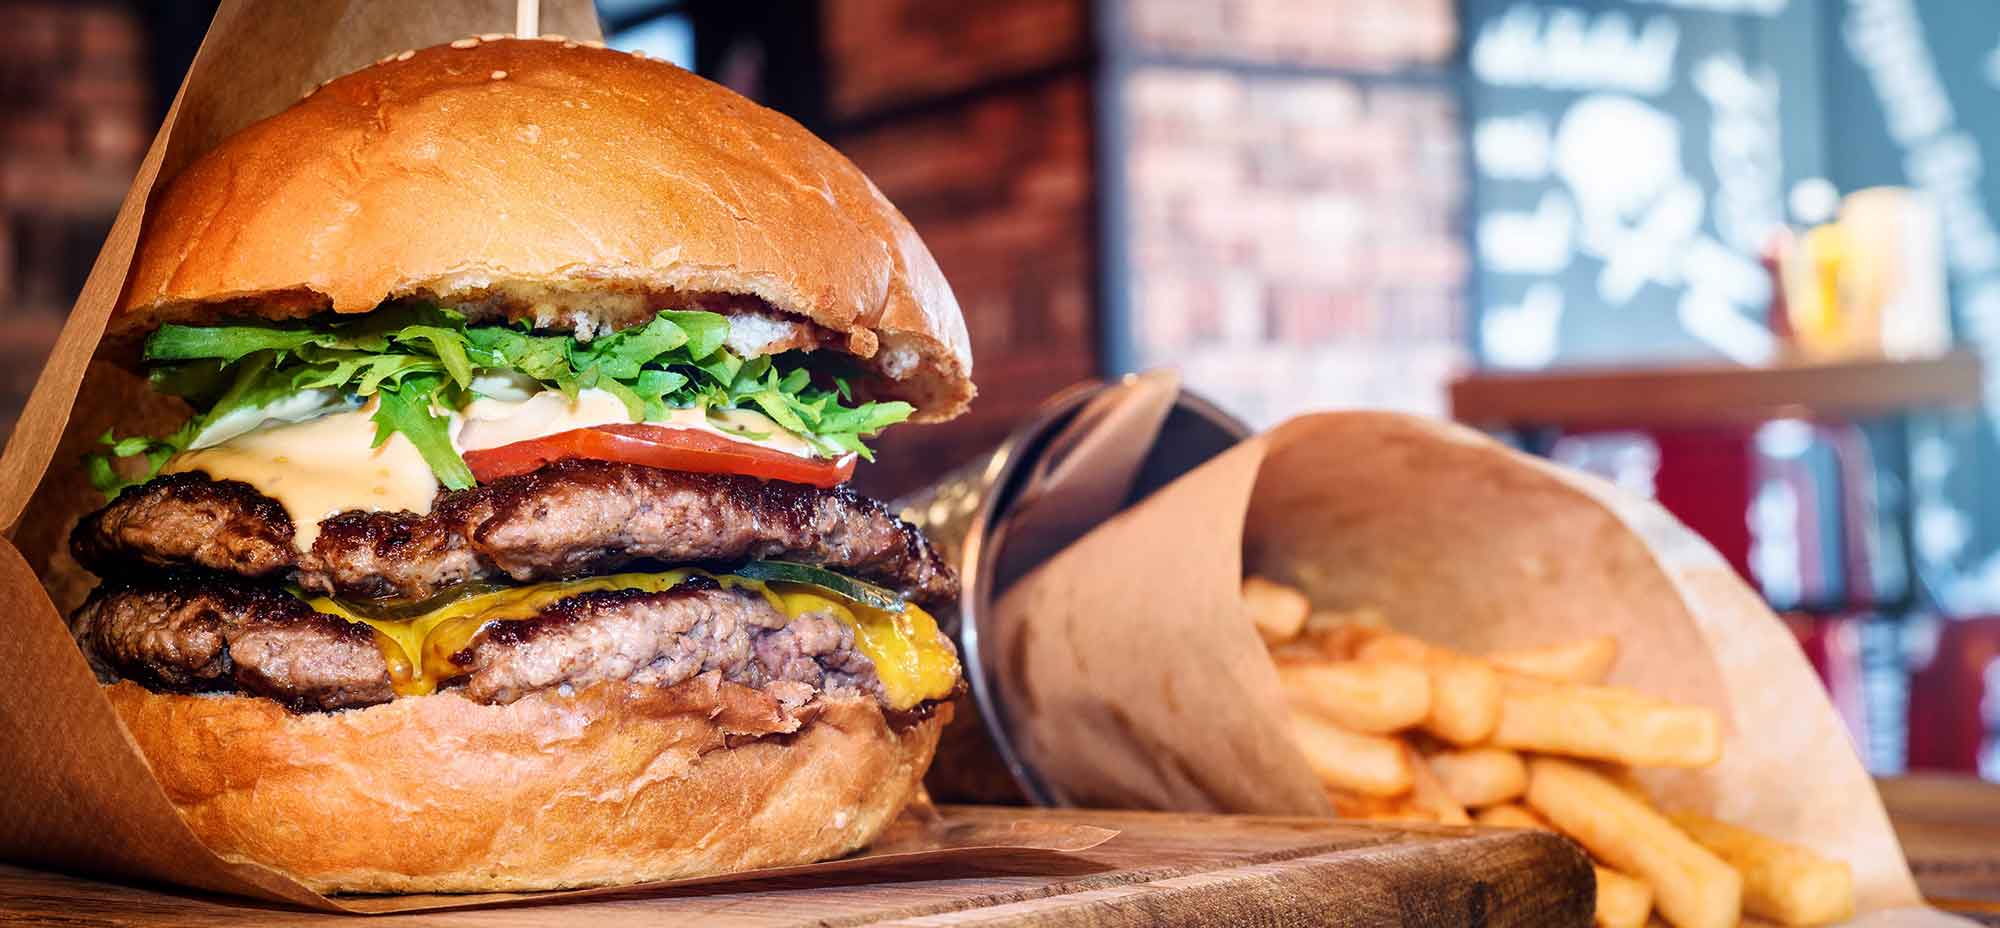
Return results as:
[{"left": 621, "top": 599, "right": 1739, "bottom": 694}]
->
[{"left": 70, "top": 574, "right": 882, "bottom": 710}]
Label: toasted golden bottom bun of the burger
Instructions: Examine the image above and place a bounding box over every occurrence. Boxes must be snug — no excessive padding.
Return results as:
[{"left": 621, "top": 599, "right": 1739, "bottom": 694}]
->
[{"left": 104, "top": 674, "right": 948, "bottom": 892}]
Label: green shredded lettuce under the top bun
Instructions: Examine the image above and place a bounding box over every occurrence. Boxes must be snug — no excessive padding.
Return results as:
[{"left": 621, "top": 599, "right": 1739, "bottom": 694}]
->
[{"left": 86, "top": 306, "right": 912, "bottom": 496}]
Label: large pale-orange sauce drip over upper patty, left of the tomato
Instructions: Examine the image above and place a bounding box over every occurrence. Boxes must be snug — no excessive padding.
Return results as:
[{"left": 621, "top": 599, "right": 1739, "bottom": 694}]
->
[{"left": 162, "top": 402, "right": 438, "bottom": 550}]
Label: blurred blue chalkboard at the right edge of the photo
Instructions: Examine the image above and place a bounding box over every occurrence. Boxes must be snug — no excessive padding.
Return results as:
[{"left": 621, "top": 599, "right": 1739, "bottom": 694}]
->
[{"left": 1824, "top": 0, "right": 2000, "bottom": 612}]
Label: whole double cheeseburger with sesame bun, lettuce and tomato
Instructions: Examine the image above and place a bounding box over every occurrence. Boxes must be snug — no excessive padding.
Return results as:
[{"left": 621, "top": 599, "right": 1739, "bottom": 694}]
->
[{"left": 70, "top": 36, "right": 974, "bottom": 892}]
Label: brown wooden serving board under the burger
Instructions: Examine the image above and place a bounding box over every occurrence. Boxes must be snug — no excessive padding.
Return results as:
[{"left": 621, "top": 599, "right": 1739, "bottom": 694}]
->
[{"left": 0, "top": 806, "right": 1592, "bottom": 928}]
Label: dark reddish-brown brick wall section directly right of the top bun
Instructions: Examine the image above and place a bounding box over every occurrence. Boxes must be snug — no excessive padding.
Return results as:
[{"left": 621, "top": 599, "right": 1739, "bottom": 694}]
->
[{"left": 824, "top": 0, "right": 1098, "bottom": 498}]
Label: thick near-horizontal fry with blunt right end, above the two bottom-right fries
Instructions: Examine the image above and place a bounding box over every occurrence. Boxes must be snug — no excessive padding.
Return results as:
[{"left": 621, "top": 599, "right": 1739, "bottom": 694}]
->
[{"left": 1492, "top": 674, "right": 1722, "bottom": 766}]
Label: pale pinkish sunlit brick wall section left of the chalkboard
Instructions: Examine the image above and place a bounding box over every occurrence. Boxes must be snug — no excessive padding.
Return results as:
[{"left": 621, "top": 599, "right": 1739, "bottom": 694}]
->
[{"left": 1118, "top": 0, "right": 1468, "bottom": 424}]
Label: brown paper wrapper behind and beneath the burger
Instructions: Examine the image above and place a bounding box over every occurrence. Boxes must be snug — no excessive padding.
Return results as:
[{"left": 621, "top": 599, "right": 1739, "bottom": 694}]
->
[{"left": 0, "top": 0, "right": 1114, "bottom": 912}]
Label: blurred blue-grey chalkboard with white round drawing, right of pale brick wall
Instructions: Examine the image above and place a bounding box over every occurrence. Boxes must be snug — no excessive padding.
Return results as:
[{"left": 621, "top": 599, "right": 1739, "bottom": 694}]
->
[{"left": 1464, "top": 0, "right": 1824, "bottom": 368}]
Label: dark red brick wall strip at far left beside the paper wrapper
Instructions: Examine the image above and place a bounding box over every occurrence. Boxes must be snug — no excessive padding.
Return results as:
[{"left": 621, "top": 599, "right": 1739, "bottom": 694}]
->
[{"left": 0, "top": 0, "right": 154, "bottom": 446}]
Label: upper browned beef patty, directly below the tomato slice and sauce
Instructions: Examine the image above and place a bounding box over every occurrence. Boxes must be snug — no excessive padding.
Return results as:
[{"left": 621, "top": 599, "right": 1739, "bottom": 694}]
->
[{"left": 70, "top": 460, "right": 958, "bottom": 602}]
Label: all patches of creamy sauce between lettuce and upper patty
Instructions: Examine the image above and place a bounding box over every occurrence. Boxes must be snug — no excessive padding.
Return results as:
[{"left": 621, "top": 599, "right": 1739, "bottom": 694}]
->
[{"left": 162, "top": 390, "right": 818, "bottom": 550}]
